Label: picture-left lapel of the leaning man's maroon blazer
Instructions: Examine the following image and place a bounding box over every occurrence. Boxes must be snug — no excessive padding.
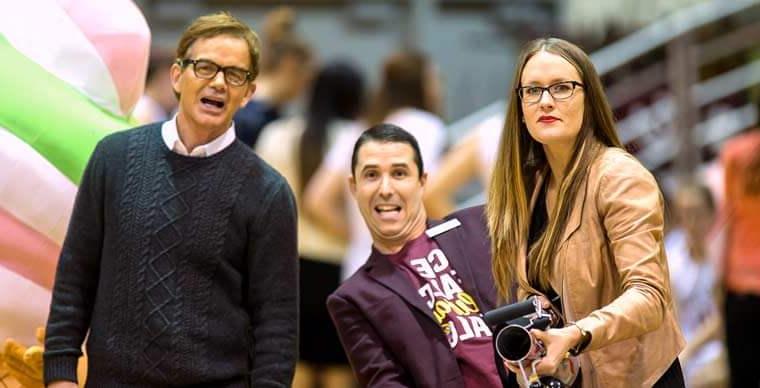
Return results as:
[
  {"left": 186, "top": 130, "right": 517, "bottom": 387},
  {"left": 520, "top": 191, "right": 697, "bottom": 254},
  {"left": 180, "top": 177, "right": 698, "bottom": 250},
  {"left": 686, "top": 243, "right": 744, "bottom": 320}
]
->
[{"left": 365, "top": 249, "right": 433, "bottom": 319}]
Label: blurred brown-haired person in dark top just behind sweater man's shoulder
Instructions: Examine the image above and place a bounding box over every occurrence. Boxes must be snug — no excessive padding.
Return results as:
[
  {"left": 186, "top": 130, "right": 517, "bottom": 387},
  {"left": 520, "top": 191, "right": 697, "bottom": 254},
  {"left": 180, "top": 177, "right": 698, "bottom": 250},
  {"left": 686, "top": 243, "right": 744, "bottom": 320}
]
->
[{"left": 235, "top": 7, "right": 312, "bottom": 147}]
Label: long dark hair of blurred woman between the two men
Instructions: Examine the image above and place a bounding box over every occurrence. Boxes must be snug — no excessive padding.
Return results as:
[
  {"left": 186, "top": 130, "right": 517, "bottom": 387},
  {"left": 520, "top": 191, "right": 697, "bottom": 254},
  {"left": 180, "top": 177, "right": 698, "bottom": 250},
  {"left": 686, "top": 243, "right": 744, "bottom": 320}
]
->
[{"left": 298, "top": 62, "right": 364, "bottom": 191}]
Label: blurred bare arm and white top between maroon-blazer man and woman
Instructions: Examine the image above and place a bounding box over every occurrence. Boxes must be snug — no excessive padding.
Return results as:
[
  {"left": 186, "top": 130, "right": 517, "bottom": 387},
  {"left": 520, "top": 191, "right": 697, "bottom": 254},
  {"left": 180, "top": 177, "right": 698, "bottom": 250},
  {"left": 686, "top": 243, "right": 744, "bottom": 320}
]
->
[{"left": 425, "top": 113, "right": 504, "bottom": 218}]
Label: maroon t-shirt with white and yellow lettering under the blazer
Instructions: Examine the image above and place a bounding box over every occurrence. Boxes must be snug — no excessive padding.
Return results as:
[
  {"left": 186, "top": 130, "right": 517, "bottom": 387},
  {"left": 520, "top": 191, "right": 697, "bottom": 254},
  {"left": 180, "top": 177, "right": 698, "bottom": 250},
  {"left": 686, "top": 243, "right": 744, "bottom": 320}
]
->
[{"left": 388, "top": 233, "right": 502, "bottom": 387}]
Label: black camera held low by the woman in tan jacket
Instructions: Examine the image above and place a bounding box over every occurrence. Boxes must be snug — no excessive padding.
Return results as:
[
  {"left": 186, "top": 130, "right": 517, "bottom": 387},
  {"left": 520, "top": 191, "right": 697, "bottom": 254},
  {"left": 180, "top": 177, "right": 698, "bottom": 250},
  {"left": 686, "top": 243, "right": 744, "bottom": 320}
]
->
[{"left": 483, "top": 296, "right": 575, "bottom": 388}]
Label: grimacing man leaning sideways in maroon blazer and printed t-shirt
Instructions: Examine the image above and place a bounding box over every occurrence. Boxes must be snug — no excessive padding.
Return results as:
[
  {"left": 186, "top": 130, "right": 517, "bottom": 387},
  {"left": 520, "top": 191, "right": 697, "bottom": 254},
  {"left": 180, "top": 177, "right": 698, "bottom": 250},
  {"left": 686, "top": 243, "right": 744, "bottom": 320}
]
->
[{"left": 327, "top": 124, "right": 505, "bottom": 388}]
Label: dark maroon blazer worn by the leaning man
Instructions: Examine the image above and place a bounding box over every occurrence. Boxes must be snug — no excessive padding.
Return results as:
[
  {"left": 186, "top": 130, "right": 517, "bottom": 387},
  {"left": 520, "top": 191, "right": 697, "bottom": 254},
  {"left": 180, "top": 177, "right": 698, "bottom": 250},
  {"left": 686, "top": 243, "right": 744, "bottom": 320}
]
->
[{"left": 327, "top": 206, "right": 504, "bottom": 388}]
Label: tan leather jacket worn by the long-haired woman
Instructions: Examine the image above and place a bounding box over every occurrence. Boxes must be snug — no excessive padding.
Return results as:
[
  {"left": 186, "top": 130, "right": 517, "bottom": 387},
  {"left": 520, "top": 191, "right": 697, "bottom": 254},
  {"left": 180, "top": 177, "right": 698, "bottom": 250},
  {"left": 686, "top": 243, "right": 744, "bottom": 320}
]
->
[{"left": 517, "top": 148, "right": 685, "bottom": 388}]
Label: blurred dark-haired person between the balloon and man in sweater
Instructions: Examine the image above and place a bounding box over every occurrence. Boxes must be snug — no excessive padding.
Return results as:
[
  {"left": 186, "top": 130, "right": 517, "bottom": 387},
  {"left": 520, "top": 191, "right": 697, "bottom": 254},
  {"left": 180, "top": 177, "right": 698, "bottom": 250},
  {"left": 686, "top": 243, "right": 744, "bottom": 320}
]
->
[{"left": 132, "top": 50, "right": 177, "bottom": 124}]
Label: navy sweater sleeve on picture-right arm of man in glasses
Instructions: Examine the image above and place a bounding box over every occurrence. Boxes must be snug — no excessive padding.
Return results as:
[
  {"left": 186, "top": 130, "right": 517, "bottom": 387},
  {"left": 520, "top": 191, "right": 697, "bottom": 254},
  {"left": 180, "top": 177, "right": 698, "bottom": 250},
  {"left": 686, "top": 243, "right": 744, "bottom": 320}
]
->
[{"left": 248, "top": 179, "right": 298, "bottom": 388}]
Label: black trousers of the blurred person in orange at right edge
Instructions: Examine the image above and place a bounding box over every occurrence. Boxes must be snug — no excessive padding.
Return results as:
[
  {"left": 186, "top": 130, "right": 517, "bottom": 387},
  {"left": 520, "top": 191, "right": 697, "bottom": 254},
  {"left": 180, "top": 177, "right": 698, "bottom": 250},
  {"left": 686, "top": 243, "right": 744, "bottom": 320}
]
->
[{"left": 725, "top": 292, "right": 760, "bottom": 388}]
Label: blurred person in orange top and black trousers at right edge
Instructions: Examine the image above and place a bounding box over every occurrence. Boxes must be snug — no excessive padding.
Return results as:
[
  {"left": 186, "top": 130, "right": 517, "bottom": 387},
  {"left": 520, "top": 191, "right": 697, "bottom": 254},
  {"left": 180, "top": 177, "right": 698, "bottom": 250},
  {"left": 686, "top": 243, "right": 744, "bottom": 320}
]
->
[{"left": 721, "top": 129, "right": 760, "bottom": 387}]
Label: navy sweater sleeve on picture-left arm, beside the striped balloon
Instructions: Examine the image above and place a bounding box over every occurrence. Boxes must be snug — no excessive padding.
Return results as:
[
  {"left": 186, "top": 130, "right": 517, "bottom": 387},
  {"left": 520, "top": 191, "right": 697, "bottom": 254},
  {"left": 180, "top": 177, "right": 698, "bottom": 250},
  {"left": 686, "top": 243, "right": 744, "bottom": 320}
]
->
[{"left": 44, "top": 141, "right": 105, "bottom": 384}]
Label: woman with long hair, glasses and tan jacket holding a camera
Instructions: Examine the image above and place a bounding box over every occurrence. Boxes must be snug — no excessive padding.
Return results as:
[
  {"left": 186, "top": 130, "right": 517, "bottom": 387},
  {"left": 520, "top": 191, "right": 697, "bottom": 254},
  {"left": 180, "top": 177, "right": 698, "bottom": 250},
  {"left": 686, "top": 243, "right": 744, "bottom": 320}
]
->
[{"left": 487, "top": 38, "right": 684, "bottom": 387}]
